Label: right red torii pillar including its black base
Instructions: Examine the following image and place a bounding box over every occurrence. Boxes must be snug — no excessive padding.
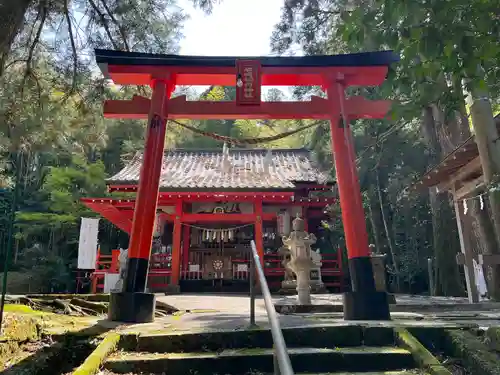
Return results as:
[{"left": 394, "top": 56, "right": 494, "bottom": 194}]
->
[{"left": 327, "top": 79, "right": 390, "bottom": 320}]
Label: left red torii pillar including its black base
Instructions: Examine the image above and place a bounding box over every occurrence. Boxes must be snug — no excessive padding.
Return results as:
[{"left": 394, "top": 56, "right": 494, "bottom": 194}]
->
[{"left": 108, "top": 77, "right": 174, "bottom": 323}]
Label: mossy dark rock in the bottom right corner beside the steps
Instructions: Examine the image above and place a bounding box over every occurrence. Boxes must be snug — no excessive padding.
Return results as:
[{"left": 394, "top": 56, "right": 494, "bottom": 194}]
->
[{"left": 445, "top": 330, "right": 500, "bottom": 375}]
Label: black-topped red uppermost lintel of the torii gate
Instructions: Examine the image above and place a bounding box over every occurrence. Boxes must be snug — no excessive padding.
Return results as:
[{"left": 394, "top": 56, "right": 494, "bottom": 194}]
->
[{"left": 95, "top": 49, "right": 399, "bottom": 86}]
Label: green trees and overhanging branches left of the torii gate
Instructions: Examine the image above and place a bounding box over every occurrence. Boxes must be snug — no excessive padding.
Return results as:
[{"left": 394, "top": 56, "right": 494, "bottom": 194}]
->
[{"left": 0, "top": 0, "right": 191, "bottom": 291}]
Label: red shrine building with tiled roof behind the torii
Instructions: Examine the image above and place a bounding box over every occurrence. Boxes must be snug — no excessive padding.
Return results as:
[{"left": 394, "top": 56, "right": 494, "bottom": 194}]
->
[{"left": 82, "top": 146, "right": 344, "bottom": 292}]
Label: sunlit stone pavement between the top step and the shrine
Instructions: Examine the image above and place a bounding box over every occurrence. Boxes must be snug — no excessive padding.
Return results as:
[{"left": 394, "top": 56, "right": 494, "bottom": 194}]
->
[{"left": 105, "top": 294, "right": 500, "bottom": 333}]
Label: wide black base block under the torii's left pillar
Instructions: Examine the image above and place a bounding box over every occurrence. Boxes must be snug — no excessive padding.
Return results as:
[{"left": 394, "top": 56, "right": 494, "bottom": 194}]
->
[{"left": 108, "top": 292, "right": 156, "bottom": 323}]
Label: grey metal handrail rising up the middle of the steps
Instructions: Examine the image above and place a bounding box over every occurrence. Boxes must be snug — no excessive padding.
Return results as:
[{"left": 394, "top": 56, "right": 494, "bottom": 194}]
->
[{"left": 250, "top": 240, "right": 294, "bottom": 375}]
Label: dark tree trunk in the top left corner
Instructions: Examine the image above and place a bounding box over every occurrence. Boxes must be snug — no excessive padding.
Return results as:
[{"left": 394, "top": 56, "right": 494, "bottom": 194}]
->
[{"left": 0, "top": 0, "right": 33, "bottom": 77}]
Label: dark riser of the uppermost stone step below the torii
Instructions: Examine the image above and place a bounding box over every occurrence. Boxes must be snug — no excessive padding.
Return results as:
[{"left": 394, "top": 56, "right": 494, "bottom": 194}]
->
[{"left": 122, "top": 324, "right": 394, "bottom": 353}]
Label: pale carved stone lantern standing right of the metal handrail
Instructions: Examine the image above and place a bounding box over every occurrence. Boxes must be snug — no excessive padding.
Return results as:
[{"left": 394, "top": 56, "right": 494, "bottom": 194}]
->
[{"left": 283, "top": 217, "right": 316, "bottom": 305}]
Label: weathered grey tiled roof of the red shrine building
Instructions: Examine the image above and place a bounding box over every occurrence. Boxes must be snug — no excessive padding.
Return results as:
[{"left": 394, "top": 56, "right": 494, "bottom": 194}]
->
[{"left": 107, "top": 149, "right": 328, "bottom": 190}]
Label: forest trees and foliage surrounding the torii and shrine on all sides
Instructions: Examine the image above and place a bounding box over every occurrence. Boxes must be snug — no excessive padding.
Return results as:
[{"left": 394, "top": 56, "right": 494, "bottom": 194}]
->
[{"left": 0, "top": 0, "right": 500, "bottom": 297}]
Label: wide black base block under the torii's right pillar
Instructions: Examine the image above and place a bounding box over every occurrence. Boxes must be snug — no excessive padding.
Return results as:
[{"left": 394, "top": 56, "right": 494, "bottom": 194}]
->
[{"left": 344, "top": 291, "right": 391, "bottom": 320}]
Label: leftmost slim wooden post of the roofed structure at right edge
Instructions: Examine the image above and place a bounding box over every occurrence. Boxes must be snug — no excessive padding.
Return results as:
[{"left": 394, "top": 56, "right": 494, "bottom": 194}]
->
[{"left": 452, "top": 189, "right": 479, "bottom": 303}]
